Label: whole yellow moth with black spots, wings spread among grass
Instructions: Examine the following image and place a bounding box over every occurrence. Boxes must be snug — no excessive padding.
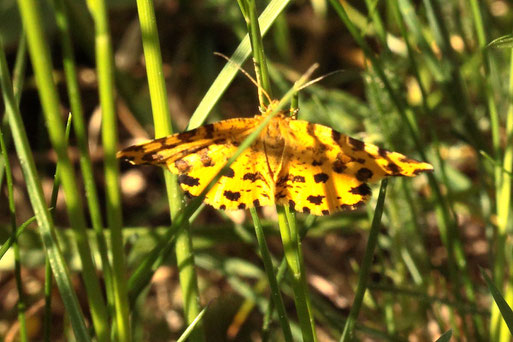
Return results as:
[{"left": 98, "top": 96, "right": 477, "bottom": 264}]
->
[{"left": 117, "top": 102, "right": 433, "bottom": 215}]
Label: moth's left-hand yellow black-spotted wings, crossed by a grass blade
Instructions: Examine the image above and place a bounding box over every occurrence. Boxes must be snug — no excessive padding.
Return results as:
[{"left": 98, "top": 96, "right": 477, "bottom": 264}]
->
[{"left": 117, "top": 118, "right": 274, "bottom": 210}]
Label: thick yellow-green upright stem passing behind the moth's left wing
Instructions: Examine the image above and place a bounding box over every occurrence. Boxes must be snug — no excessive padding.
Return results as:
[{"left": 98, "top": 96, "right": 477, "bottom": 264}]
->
[{"left": 137, "top": 0, "right": 205, "bottom": 342}]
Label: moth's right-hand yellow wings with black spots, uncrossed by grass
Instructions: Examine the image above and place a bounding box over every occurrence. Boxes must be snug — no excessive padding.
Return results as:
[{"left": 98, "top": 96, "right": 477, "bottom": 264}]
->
[{"left": 276, "top": 120, "right": 433, "bottom": 215}]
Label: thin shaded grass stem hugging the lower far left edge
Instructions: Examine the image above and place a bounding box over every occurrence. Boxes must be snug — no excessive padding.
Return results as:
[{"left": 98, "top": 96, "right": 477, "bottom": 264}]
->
[{"left": 0, "top": 125, "right": 27, "bottom": 342}]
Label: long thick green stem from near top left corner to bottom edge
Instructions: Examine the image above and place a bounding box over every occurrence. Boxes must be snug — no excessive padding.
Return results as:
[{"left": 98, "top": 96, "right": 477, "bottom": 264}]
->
[{"left": 18, "top": 0, "right": 109, "bottom": 342}]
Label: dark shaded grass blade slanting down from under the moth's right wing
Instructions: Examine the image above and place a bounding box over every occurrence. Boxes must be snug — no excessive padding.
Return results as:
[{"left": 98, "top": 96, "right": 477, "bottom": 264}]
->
[{"left": 340, "top": 178, "right": 388, "bottom": 342}]
